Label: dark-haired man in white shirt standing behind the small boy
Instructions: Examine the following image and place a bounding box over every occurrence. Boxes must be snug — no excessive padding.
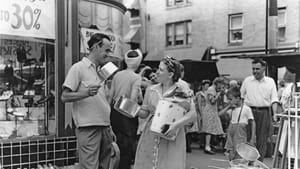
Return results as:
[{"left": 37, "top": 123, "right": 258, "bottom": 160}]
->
[{"left": 241, "top": 59, "right": 278, "bottom": 161}]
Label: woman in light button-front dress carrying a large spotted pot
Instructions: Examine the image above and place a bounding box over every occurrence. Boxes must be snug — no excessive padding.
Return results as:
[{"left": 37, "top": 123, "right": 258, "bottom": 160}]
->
[{"left": 134, "top": 57, "right": 196, "bottom": 169}]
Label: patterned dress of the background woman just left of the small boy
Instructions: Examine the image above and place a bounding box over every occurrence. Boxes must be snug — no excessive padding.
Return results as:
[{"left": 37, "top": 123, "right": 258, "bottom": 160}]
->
[{"left": 202, "top": 86, "right": 224, "bottom": 135}]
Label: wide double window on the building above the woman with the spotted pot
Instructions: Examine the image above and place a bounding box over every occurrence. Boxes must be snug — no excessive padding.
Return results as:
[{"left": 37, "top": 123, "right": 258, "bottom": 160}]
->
[{"left": 165, "top": 20, "right": 192, "bottom": 48}]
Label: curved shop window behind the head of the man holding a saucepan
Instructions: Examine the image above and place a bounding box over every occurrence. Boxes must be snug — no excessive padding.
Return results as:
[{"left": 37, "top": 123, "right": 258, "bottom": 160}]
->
[{"left": 78, "top": 0, "right": 123, "bottom": 58}]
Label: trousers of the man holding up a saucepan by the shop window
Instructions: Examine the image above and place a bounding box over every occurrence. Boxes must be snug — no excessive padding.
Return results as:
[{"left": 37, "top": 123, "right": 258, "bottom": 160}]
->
[{"left": 76, "top": 126, "right": 112, "bottom": 169}]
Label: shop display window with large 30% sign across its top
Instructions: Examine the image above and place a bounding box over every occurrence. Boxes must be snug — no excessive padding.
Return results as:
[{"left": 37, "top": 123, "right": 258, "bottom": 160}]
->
[{"left": 0, "top": 0, "right": 55, "bottom": 139}]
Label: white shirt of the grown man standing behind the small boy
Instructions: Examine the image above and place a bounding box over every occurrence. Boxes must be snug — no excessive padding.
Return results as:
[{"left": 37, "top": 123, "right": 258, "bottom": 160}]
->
[{"left": 241, "top": 76, "right": 278, "bottom": 107}]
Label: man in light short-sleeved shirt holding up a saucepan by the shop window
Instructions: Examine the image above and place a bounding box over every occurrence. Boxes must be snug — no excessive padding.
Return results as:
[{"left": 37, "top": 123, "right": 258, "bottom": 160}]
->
[{"left": 61, "top": 33, "right": 114, "bottom": 169}]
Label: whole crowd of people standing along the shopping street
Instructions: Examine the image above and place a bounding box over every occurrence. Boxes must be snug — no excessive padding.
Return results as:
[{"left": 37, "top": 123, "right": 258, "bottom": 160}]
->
[{"left": 61, "top": 33, "right": 284, "bottom": 169}]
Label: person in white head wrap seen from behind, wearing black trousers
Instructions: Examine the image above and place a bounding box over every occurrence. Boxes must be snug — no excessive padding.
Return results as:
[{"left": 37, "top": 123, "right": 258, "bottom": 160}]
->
[{"left": 110, "top": 49, "right": 143, "bottom": 169}]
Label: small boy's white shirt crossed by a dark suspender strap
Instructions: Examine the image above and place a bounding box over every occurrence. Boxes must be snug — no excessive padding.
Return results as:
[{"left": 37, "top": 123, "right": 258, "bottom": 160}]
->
[{"left": 227, "top": 105, "right": 254, "bottom": 124}]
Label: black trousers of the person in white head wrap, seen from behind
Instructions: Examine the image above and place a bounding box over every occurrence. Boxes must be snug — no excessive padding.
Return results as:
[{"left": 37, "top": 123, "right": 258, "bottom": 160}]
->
[{"left": 110, "top": 106, "right": 138, "bottom": 169}]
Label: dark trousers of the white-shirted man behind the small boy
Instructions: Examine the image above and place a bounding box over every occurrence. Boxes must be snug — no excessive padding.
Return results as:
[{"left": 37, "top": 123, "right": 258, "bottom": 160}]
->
[{"left": 251, "top": 107, "right": 273, "bottom": 161}]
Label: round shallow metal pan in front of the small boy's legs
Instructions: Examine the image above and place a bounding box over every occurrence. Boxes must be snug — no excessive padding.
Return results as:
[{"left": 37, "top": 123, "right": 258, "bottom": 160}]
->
[{"left": 236, "top": 143, "right": 260, "bottom": 161}]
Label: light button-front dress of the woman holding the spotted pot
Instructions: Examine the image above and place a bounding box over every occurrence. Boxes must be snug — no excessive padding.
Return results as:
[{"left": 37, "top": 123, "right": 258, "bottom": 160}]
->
[{"left": 134, "top": 84, "right": 191, "bottom": 169}]
